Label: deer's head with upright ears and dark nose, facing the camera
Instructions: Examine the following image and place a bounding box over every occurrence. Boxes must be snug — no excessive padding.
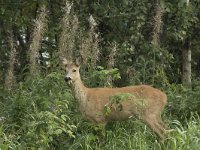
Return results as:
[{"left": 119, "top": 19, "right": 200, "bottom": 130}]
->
[{"left": 63, "top": 59, "right": 81, "bottom": 82}]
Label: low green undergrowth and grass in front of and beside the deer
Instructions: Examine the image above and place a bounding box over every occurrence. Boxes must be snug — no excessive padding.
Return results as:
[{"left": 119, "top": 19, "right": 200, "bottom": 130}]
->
[{"left": 0, "top": 72, "right": 200, "bottom": 150}]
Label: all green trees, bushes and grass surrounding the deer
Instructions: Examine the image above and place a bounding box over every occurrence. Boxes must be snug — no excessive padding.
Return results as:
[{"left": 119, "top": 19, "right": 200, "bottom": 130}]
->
[{"left": 0, "top": 0, "right": 200, "bottom": 150}]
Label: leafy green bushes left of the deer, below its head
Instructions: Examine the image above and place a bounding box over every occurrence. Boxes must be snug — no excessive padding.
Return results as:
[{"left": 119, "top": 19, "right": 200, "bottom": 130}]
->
[{"left": 0, "top": 73, "right": 76, "bottom": 149}]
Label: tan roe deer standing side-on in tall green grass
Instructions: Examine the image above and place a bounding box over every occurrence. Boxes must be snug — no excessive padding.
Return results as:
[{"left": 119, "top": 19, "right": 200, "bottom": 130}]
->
[{"left": 63, "top": 59, "right": 167, "bottom": 139}]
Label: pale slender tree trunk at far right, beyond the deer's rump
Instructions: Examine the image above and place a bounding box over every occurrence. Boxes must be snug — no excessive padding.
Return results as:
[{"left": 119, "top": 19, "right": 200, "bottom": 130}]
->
[{"left": 182, "top": 39, "right": 191, "bottom": 88}]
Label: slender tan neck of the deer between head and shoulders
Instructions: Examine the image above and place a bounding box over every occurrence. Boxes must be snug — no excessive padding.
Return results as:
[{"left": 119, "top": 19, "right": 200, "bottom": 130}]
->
[{"left": 72, "top": 78, "right": 87, "bottom": 104}]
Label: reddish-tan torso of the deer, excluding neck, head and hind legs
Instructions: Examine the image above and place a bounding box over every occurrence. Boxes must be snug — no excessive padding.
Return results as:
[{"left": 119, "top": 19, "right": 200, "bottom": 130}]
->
[{"left": 85, "top": 85, "right": 167, "bottom": 120}]
